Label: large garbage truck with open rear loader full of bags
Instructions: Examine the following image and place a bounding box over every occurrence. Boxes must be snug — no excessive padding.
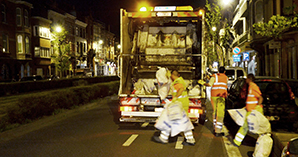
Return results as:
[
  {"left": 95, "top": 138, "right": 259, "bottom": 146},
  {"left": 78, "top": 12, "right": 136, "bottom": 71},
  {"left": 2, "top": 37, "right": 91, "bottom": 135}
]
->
[{"left": 117, "top": 6, "right": 207, "bottom": 123}]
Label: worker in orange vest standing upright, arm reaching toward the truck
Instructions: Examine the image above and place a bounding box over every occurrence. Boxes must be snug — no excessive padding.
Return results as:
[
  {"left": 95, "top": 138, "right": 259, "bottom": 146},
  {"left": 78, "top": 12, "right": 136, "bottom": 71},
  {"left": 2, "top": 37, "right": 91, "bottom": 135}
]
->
[{"left": 199, "top": 66, "right": 228, "bottom": 137}]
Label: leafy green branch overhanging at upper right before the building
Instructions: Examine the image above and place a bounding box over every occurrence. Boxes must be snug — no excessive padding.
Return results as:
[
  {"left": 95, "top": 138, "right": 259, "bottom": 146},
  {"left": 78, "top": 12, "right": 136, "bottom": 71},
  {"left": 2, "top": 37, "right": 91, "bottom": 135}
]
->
[{"left": 253, "top": 8, "right": 298, "bottom": 40}]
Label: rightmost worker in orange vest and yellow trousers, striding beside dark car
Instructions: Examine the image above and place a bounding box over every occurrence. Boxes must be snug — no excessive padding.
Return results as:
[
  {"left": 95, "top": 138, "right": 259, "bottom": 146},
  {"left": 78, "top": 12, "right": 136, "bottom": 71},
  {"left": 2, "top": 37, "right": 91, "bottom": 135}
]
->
[{"left": 229, "top": 74, "right": 263, "bottom": 147}]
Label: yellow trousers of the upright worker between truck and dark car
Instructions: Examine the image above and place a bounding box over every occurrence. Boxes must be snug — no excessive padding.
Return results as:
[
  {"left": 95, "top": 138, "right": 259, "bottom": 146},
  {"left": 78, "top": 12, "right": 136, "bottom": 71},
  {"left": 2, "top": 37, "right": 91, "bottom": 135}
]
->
[{"left": 211, "top": 97, "right": 225, "bottom": 133}]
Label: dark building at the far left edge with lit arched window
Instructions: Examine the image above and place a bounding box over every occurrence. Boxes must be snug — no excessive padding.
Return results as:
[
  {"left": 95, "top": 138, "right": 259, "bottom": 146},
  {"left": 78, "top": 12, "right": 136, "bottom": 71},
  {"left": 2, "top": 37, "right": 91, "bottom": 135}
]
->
[{"left": 0, "top": 0, "right": 33, "bottom": 81}]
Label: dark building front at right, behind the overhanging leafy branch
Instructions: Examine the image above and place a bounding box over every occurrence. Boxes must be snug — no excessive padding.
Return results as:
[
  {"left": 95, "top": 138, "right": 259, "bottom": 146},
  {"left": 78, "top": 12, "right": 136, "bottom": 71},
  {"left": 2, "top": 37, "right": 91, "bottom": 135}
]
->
[{"left": 230, "top": 0, "right": 298, "bottom": 79}]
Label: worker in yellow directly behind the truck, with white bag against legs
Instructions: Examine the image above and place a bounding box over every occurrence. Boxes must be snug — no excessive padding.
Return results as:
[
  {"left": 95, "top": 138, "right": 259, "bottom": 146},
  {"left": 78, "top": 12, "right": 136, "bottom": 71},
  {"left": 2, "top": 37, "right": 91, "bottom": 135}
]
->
[{"left": 153, "top": 70, "right": 195, "bottom": 146}]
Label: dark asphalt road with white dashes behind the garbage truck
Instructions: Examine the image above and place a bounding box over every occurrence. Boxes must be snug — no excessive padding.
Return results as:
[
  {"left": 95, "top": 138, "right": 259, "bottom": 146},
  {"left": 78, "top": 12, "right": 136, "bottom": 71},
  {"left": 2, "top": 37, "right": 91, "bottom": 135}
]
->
[{"left": 0, "top": 96, "right": 255, "bottom": 157}]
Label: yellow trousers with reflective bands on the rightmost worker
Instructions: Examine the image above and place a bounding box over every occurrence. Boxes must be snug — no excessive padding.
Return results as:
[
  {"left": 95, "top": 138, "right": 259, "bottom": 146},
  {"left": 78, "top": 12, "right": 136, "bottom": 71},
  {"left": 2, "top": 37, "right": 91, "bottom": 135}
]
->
[{"left": 234, "top": 105, "right": 263, "bottom": 146}]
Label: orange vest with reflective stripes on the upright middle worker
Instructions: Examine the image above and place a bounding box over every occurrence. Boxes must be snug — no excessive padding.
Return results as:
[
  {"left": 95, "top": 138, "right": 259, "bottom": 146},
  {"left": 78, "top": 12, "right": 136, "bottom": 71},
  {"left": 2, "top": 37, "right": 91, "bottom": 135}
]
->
[{"left": 211, "top": 73, "right": 228, "bottom": 98}]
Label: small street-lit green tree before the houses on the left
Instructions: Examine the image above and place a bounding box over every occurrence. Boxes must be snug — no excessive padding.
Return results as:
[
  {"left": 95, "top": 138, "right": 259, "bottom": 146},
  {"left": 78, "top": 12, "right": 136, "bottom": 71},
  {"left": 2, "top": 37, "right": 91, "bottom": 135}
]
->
[{"left": 52, "top": 26, "right": 71, "bottom": 77}]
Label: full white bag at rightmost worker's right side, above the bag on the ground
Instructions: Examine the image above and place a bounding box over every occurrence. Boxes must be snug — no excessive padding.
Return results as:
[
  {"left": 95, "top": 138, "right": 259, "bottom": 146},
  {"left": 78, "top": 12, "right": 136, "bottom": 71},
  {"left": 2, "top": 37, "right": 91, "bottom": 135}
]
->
[{"left": 247, "top": 110, "right": 271, "bottom": 134}]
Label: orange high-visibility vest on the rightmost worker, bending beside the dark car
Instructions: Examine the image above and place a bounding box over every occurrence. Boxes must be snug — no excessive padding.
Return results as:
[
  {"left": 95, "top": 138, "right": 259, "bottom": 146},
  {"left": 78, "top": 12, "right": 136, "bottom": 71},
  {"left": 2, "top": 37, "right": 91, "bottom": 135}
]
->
[{"left": 246, "top": 82, "right": 262, "bottom": 111}]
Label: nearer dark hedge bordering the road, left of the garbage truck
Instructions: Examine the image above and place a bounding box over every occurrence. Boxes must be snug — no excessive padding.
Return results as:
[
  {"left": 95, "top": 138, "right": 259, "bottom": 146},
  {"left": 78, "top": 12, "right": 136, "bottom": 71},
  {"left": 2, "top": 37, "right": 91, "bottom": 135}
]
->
[{"left": 0, "top": 81, "right": 119, "bottom": 132}]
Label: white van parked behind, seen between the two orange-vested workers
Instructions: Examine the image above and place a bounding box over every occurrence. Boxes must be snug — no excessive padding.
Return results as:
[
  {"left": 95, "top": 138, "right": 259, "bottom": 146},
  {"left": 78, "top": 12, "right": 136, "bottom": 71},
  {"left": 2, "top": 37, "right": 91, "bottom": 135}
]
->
[{"left": 225, "top": 67, "right": 247, "bottom": 89}]
